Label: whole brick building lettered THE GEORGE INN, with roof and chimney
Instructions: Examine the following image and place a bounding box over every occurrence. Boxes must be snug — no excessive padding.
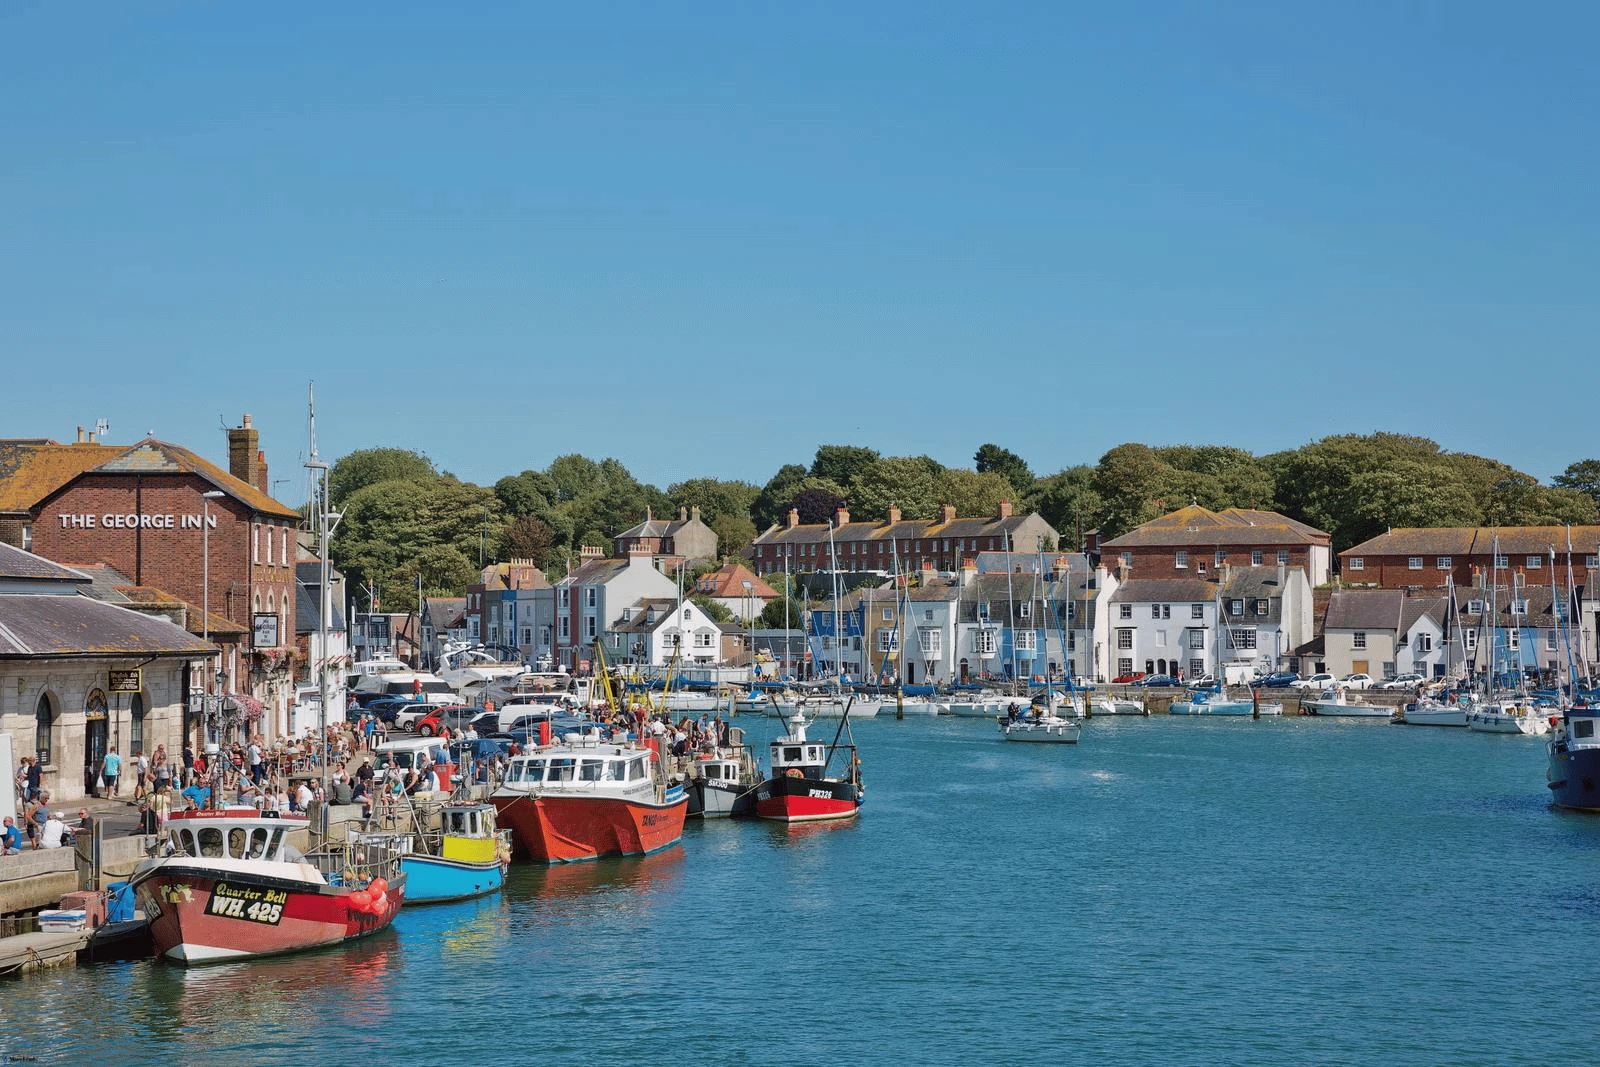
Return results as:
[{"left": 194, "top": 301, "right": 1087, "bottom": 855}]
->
[{"left": 0, "top": 414, "right": 299, "bottom": 736}]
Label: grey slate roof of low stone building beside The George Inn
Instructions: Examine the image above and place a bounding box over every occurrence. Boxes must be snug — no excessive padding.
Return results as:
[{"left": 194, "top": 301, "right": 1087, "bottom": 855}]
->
[{"left": 0, "top": 593, "right": 214, "bottom": 659}]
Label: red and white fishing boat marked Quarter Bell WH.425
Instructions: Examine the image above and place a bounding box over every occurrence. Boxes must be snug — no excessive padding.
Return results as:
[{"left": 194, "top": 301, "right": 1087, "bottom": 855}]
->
[{"left": 133, "top": 808, "right": 405, "bottom": 965}]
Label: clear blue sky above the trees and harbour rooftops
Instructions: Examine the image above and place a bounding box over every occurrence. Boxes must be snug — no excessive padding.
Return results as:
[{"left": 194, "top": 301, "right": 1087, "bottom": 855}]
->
[{"left": 0, "top": 0, "right": 1600, "bottom": 499}]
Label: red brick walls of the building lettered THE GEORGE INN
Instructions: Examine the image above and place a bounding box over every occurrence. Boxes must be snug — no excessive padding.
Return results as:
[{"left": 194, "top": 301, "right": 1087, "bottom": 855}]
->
[{"left": 34, "top": 474, "right": 294, "bottom": 646}]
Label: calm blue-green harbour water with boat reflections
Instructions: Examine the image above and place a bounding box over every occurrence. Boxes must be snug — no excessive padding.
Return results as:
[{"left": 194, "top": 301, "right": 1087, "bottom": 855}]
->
[{"left": 0, "top": 717, "right": 1600, "bottom": 1064}]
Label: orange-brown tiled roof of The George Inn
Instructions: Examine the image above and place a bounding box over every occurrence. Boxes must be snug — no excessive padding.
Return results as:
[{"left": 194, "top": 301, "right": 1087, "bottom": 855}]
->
[{"left": 0, "top": 437, "right": 299, "bottom": 518}]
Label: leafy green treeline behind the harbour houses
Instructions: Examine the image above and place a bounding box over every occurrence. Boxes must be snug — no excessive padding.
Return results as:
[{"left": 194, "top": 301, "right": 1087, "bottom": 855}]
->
[{"left": 330, "top": 434, "right": 1600, "bottom": 606}]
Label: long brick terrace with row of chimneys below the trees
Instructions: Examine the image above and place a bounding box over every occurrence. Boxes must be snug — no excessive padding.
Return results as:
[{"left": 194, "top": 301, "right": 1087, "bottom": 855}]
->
[{"left": 744, "top": 501, "right": 1058, "bottom": 574}]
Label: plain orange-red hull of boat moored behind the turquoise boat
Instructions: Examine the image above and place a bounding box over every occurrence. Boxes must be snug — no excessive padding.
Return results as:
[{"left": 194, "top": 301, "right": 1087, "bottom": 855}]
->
[{"left": 490, "top": 793, "right": 690, "bottom": 864}]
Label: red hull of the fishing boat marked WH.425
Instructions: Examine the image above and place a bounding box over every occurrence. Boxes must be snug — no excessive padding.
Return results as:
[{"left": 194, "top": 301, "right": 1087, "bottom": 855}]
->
[{"left": 134, "top": 861, "right": 406, "bottom": 966}]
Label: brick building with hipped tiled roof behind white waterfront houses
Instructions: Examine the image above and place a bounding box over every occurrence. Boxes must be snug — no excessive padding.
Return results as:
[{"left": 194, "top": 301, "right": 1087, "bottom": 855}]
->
[{"left": 1099, "top": 504, "right": 1333, "bottom": 585}]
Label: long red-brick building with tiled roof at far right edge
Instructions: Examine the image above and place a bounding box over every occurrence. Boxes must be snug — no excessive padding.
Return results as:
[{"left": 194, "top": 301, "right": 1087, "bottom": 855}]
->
[{"left": 1339, "top": 526, "right": 1600, "bottom": 589}]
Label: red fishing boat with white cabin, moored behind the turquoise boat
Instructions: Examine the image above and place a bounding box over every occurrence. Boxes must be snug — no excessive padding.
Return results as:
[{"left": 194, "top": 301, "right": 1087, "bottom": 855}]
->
[{"left": 490, "top": 731, "right": 690, "bottom": 864}]
